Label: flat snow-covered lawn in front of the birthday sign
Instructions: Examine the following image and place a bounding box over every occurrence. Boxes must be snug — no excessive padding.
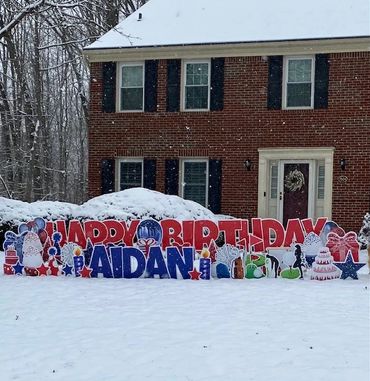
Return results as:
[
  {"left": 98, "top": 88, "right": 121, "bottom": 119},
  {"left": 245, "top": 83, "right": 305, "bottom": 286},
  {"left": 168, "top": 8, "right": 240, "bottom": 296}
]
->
[{"left": 0, "top": 252, "right": 370, "bottom": 381}]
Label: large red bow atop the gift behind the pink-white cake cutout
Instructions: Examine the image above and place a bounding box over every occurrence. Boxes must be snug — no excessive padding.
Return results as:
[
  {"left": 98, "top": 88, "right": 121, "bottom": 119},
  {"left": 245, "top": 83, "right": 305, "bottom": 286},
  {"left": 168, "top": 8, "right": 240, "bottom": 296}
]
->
[{"left": 326, "top": 232, "right": 360, "bottom": 262}]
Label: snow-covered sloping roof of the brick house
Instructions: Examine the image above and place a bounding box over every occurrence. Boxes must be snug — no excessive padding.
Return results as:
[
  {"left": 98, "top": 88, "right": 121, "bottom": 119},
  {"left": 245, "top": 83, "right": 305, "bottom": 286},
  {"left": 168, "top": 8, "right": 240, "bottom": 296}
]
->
[{"left": 86, "top": 0, "right": 370, "bottom": 50}]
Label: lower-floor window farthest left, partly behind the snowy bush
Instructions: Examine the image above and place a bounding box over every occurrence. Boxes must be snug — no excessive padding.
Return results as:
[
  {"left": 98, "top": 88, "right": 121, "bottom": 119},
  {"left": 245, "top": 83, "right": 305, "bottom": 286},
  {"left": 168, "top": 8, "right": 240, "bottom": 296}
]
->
[{"left": 117, "top": 159, "right": 144, "bottom": 190}]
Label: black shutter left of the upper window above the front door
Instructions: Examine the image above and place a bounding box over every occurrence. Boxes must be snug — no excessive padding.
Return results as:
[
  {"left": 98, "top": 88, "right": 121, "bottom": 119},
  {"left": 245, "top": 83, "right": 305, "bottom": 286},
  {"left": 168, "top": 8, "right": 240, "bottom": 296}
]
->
[{"left": 267, "top": 56, "right": 283, "bottom": 110}]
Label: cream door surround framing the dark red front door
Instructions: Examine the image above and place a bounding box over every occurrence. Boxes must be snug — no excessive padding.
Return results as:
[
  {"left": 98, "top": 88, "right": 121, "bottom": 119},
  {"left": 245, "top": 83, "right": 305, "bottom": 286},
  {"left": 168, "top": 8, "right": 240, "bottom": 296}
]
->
[{"left": 258, "top": 147, "right": 334, "bottom": 218}]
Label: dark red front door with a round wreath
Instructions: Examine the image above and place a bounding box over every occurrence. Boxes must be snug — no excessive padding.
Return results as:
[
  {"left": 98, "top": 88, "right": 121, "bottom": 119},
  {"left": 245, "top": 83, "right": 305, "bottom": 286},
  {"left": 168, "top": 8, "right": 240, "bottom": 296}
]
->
[{"left": 279, "top": 161, "right": 311, "bottom": 226}]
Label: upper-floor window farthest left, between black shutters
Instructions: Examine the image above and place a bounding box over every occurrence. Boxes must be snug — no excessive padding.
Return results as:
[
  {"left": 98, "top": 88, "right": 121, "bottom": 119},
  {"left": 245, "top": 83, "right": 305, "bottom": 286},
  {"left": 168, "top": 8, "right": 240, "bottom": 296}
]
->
[{"left": 120, "top": 63, "right": 144, "bottom": 111}]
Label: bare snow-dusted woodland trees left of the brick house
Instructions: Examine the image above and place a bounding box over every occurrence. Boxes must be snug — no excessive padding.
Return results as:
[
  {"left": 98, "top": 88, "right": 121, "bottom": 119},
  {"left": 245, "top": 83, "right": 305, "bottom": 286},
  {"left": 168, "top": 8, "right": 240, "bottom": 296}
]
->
[{"left": 0, "top": 0, "right": 146, "bottom": 202}]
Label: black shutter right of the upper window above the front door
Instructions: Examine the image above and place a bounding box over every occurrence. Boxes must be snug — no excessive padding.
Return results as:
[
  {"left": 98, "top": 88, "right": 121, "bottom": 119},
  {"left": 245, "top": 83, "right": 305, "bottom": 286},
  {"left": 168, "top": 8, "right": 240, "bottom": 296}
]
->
[{"left": 314, "top": 54, "right": 329, "bottom": 108}]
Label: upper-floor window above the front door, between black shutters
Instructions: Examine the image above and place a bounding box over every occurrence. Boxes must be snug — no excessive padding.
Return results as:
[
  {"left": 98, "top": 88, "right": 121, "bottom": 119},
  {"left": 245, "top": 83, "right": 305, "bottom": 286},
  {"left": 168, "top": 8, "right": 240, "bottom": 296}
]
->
[{"left": 283, "top": 57, "right": 315, "bottom": 108}]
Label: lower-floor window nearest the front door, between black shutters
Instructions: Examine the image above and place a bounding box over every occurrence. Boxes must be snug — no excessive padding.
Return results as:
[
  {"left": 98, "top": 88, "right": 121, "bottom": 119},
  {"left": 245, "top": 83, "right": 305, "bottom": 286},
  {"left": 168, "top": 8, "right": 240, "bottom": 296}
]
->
[{"left": 181, "top": 159, "right": 208, "bottom": 207}]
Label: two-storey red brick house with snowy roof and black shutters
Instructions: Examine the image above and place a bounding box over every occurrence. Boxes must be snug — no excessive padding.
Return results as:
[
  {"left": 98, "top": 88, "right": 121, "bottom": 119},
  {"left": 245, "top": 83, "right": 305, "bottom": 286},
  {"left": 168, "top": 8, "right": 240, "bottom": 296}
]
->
[{"left": 85, "top": 0, "right": 370, "bottom": 230}]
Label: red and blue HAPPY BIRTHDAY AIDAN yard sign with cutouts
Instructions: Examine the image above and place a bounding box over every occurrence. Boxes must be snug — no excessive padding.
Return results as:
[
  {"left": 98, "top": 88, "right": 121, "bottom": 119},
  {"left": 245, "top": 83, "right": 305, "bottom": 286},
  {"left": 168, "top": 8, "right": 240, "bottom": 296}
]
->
[{"left": 3, "top": 218, "right": 363, "bottom": 280}]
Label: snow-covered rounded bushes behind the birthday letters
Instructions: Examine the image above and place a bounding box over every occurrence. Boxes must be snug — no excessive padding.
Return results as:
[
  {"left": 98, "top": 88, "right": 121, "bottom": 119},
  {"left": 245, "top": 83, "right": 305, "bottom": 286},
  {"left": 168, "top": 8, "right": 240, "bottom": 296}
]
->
[{"left": 0, "top": 188, "right": 216, "bottom": 225}]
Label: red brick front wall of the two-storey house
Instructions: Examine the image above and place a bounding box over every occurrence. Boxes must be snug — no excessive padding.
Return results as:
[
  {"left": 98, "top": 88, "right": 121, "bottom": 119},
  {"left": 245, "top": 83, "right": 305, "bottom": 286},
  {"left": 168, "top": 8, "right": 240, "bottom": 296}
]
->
[{"left": 89, "top": 53, "right": 370, "bottom": 230}]
